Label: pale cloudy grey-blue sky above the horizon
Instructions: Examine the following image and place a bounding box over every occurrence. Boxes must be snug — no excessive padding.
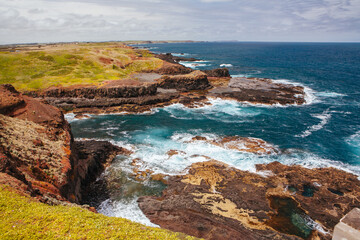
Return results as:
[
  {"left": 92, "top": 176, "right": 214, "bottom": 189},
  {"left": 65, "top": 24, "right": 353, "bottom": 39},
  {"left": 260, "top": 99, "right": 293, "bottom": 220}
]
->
[{"left": 0, "top": 0, "right": 360, "bottom": 44}]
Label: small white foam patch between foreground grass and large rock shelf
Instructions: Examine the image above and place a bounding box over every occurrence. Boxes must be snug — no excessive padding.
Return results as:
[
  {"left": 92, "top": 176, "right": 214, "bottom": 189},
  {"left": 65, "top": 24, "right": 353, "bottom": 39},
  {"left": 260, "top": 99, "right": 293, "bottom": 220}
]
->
[{"left": 97, "top": 198, "right": 159, "bottom": 227}]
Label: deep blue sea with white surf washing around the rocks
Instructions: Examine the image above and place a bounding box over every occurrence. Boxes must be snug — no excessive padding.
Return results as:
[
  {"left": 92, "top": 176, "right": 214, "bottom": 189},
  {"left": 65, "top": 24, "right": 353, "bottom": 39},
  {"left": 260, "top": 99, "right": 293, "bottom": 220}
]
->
[{"left": 68, "top": 42, "right": 360, "bottom": 225}]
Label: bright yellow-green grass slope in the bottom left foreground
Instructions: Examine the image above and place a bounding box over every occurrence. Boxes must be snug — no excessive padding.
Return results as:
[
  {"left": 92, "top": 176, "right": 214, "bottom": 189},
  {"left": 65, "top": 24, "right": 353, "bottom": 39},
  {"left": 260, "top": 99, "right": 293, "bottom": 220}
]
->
[{"left": 0, "top": 185, "right": 195, "bottom": 240}]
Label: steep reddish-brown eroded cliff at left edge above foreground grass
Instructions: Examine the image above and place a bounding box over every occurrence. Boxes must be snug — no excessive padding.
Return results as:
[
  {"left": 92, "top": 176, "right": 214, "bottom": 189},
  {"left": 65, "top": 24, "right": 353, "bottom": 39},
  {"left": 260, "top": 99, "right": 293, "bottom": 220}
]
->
[{"left": 0, "top": 85, "right": 123, "bottom": 203}]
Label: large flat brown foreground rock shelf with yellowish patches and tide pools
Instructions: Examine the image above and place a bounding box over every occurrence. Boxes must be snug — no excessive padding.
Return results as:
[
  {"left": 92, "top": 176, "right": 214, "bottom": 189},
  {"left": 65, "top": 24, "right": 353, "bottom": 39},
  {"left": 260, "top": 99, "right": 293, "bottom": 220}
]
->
[{"left": 138, "top": 160, "right": 360, "bottom": 239}]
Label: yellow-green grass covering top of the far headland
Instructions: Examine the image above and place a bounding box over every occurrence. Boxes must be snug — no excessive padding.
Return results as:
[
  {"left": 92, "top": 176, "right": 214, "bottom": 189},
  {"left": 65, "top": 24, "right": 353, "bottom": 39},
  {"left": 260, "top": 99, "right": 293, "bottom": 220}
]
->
[{"left": 0, "top": 43, "right": 162, "bottom": 91}]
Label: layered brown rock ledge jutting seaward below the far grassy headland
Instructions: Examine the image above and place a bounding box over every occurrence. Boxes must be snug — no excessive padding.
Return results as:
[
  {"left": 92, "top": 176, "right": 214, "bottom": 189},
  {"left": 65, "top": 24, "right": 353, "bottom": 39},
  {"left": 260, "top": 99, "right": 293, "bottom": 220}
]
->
[{"left": 24, "top": 50, "right": 306, "bottom": 116}]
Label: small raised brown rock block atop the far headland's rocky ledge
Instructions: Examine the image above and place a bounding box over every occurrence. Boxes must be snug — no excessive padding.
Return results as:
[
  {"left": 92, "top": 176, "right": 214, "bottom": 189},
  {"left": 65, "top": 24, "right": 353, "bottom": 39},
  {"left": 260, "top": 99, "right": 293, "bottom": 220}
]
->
[{"left": 158, "top": 71, "right": 211, "bottom": 91}]
